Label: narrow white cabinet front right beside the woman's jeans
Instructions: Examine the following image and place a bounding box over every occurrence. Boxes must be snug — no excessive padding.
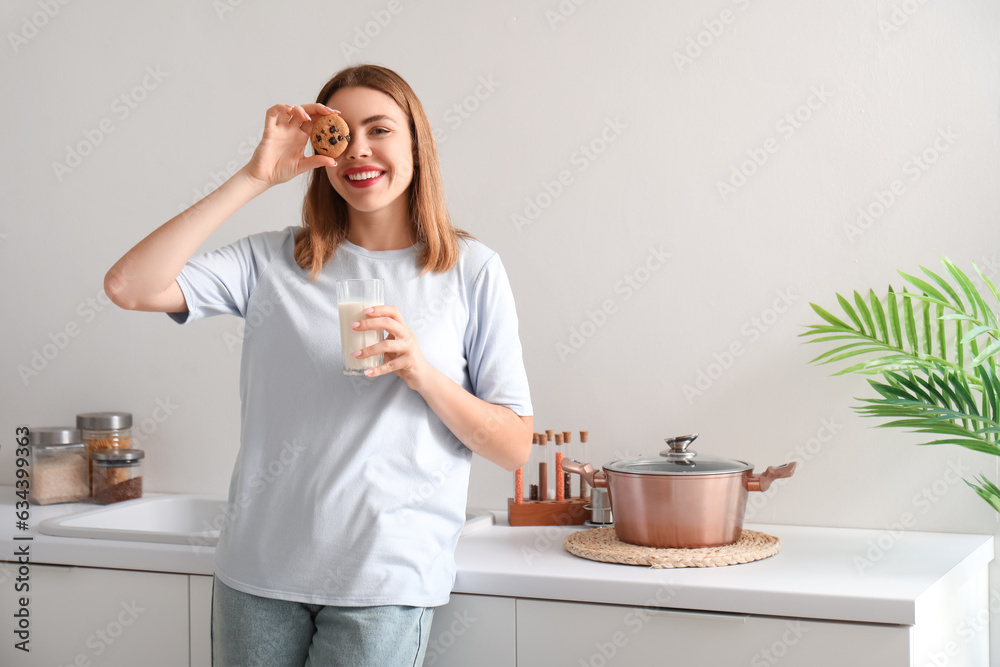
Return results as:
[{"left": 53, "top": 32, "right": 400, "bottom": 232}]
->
[{"left": 424, "top": 594, "right": 516, "bottom": 667}]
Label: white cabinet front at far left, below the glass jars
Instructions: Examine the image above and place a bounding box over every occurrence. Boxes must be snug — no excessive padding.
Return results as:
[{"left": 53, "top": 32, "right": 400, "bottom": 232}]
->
[{"left": 0, "top": 563, "right": 190, "bottom": 667}]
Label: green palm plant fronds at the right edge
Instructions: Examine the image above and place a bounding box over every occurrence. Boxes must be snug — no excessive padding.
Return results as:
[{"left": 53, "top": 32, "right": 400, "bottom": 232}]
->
[{"left": 800, "top": 258, "right": 1000, "bottom": 511}]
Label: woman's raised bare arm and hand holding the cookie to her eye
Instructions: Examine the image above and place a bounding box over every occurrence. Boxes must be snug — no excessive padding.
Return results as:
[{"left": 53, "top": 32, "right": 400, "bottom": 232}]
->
[{"left": 104, "top": 104, "right": 337, "bottom": 313}]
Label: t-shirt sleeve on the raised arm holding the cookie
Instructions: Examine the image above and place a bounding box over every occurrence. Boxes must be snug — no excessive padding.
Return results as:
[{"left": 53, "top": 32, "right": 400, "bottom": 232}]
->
[{"left": 167, "top": 233, "right": 276, "bottom": 324}]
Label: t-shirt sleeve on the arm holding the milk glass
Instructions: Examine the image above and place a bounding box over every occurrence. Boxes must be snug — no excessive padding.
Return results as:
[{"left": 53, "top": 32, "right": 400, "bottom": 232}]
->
[{"left": 465, "top": 255, "right": 533, "bottom": 417}]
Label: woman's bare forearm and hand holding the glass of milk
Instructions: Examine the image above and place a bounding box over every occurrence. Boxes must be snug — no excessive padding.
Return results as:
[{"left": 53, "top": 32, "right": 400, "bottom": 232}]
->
[{"left": 354, "top": 306, "right": 534, "bottom": 471}]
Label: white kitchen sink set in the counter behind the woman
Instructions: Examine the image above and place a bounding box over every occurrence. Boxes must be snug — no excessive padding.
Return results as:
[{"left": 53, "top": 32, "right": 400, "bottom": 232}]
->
[{"left": 38, "top": 494, "right": 495, "bottom": 547}]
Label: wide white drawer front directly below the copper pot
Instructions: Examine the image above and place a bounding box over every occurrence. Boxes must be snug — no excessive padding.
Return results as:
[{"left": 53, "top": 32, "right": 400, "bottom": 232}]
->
[{"left": 517, "top": 600, "right": 910, "bottom": 667}]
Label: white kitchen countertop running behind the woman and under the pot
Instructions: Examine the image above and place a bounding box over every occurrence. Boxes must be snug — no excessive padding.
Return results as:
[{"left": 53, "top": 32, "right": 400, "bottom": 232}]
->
[{"left": 0, "top": 487, "right": 993, "bottom": 625}]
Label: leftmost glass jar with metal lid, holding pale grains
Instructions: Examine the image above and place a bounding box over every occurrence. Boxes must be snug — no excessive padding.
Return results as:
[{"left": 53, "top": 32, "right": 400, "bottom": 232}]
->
[{"left": 28, "top": 426, "right": 90, "bottom": 505}]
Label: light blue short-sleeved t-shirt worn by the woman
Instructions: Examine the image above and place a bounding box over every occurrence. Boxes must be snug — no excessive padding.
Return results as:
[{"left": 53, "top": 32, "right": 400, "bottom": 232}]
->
[{"left": 171, "top": 227, "right": 532, "bottom": 607}]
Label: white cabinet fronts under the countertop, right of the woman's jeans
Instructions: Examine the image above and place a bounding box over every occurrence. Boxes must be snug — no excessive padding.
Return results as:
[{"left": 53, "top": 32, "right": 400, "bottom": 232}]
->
[{"left": 424, "top": 595, "right": 928, "bottom": 667}]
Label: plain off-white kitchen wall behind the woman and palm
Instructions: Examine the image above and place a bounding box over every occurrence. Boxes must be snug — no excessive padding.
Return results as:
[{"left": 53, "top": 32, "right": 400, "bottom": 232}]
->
[{"left": 0, "top": 0, "right": 1000, "bottom": 652}]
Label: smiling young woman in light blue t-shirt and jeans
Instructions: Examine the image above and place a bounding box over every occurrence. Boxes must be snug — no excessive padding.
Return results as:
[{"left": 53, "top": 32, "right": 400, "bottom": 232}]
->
[{"left": 105, "top": 65, "right": 532, "bottom": 667}]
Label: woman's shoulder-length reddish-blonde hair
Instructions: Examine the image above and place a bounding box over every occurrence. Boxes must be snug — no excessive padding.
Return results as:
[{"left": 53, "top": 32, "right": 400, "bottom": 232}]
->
[{"left": 295, "top": 65, "right": 469, "bottom": 281}]
